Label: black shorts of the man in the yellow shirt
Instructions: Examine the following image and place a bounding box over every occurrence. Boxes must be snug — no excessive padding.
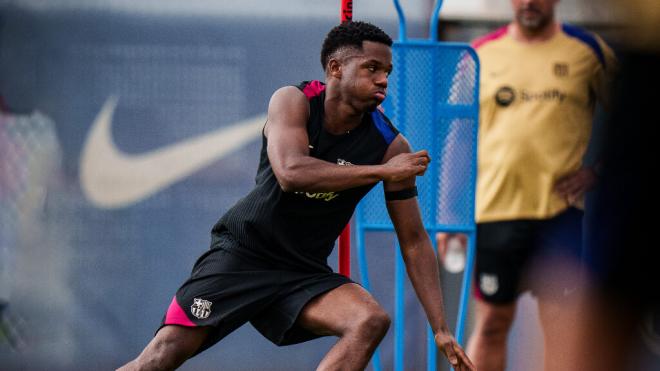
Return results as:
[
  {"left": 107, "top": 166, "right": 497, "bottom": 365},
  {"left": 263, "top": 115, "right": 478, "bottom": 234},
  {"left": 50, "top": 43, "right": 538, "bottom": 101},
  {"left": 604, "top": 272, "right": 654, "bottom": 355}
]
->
[{"left": 475, "top": 208, "right": 583, "bottom": 304}]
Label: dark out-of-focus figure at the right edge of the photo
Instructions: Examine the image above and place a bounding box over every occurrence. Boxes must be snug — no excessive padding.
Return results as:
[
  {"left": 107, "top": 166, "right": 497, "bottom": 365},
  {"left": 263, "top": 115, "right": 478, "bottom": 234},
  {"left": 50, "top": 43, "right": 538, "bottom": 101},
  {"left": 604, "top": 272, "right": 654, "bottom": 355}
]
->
[{"left": 564, "top": 0, "right": 660, "bottom": 371}]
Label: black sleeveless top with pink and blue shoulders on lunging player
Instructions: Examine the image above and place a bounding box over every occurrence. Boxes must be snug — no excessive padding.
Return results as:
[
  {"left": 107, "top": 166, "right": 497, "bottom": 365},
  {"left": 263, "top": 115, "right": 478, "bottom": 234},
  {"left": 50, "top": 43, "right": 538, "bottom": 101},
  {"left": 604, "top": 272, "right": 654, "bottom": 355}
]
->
[{"left": 212, "top": 81, "right": 399, "bottom": 272}]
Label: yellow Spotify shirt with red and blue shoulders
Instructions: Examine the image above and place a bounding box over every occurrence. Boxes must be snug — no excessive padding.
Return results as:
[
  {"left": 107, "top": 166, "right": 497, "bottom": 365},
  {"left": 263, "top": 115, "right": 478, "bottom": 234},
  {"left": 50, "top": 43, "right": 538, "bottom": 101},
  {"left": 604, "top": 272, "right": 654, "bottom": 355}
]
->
[{"left": 473, "top": 25, "right": 616, "bottom": 222}]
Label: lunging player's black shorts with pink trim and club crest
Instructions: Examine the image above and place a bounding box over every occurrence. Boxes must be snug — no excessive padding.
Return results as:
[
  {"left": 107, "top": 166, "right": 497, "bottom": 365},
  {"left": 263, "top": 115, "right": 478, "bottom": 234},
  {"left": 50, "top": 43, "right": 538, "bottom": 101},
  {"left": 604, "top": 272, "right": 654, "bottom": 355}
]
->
[{"left": 161, "top": 232, "right": 353, "bottom": 353}]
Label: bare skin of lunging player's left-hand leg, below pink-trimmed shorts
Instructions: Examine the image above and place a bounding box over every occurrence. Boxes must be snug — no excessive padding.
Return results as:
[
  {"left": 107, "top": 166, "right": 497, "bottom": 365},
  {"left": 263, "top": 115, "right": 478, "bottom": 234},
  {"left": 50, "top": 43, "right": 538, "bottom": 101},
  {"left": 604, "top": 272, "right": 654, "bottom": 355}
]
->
[{"left": 119, "top": 325, "right": 210, "bottom": 371}]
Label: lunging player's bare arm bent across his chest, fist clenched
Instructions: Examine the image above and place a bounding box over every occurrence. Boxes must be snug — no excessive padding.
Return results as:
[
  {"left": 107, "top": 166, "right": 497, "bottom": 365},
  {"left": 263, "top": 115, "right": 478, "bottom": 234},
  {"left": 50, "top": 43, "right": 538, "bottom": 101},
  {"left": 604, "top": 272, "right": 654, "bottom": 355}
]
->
[{"left": 264, "top": 86, "right": 428, "bottom": 192}]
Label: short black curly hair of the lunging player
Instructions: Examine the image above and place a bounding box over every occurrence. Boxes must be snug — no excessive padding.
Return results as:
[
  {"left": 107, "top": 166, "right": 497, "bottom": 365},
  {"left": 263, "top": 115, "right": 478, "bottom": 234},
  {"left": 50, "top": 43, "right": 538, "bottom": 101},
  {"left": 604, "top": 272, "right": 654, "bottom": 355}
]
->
[{"left": 321, "top": 21, "right": 392, "bottom": 70}]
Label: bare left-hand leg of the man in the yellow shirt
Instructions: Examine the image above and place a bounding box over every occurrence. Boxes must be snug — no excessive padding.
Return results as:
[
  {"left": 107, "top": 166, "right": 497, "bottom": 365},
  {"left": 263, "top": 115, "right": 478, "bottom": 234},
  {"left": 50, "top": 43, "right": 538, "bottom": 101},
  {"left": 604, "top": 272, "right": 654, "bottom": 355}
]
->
[{"left": 467, "top": 300, "right": 516, "bottom": 371}]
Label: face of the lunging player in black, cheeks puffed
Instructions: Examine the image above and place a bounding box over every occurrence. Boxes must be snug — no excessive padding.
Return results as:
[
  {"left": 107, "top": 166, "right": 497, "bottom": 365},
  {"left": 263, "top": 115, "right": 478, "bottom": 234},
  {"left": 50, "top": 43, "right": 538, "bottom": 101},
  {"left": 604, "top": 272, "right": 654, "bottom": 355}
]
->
[{"left": 342, "top": 41, "right": 392, "bottom": 111}]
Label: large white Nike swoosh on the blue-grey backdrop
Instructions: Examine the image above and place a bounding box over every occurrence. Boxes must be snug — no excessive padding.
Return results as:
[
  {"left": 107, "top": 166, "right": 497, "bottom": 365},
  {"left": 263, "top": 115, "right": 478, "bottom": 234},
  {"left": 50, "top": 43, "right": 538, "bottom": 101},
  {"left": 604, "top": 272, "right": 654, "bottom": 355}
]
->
[{"left": 80, "top": 96, "right": 266, "bottom": 209}]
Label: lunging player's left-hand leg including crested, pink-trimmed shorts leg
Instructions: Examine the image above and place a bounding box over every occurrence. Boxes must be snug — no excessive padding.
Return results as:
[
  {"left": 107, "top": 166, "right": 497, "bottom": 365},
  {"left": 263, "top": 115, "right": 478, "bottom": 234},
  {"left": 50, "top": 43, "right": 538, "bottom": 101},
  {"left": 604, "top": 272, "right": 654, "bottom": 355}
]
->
[{"left": 118, "top": 235, "right": 279, "bottom": 370}]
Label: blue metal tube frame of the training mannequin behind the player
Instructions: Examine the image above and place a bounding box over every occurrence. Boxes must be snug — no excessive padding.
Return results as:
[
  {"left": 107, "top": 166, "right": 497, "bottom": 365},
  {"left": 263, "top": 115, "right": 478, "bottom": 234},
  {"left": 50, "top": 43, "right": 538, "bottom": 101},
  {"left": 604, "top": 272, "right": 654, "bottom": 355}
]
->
[{"left": 355, "top": 0, "right": 480, "bottom": 371}]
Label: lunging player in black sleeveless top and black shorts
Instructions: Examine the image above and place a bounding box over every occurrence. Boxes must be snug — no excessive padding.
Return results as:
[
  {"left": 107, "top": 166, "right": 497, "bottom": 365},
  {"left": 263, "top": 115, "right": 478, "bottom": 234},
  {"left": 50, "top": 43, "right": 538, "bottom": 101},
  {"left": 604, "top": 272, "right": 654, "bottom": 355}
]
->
[{"left": 117, "top": 22, "right": 474, "bottom": 370}]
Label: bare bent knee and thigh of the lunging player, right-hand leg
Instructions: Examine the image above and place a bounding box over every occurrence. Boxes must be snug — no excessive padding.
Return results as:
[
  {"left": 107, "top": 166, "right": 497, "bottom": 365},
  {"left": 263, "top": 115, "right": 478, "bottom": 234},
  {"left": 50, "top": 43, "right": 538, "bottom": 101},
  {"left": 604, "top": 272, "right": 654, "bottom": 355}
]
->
[{"left": 296, "top": 283, "right": 390, "bottom": 370}]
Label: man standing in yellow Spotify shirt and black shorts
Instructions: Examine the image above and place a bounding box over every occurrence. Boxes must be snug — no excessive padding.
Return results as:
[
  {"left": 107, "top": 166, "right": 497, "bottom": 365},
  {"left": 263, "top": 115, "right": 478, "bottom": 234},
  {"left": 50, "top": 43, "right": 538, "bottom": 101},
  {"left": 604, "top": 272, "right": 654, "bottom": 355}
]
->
[{"left": 437, "top": 0, "right": 616, "bottom": 371}]
